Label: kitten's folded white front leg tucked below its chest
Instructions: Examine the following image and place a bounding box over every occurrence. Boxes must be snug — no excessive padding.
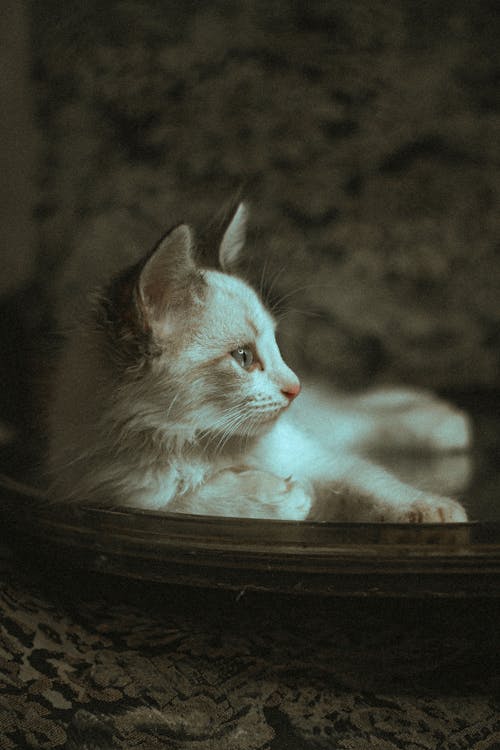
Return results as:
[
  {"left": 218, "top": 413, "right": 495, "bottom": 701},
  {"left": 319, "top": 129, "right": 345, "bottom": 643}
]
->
[{"left": 167, "top": 466, "right": 312, "bottom": 521}]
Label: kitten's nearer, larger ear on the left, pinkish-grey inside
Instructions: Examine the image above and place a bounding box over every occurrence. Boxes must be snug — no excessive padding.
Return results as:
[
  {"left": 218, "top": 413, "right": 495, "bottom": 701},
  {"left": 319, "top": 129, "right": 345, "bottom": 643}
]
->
[{"left": 139, "top": 224, "right": 199, "bottom": 320}]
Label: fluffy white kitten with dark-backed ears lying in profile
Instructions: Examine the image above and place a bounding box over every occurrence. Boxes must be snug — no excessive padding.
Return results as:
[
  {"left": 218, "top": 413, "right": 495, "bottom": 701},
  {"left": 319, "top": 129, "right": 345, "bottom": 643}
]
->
[{"left": 46, "top": 205, "right": 469, "bottom": 522}]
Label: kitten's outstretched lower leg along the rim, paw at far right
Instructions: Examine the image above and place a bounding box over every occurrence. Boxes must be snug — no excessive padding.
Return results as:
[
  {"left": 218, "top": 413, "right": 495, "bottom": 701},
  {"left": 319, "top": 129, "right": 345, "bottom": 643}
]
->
[{"left": 312, "top": 458, "right": 467, "bottom": 523}]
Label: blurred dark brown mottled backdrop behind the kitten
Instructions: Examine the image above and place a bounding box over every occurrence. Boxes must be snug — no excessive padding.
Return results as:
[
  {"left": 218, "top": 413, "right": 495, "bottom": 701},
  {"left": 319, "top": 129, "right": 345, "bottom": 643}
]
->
[{"left": 0, "top": 0, "right": 500, "bottom": 512}]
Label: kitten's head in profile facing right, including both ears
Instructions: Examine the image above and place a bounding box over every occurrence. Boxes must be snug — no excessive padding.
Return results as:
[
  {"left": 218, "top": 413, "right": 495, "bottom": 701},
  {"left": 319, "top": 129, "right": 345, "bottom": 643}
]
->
[{"left": 100, "top": 204, "right": 300, "bottom": 444}]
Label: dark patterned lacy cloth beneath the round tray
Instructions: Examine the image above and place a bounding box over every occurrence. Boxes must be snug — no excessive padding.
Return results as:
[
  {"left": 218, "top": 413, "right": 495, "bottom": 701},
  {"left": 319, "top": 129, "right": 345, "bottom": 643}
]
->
[{"left": 0, "top": 553, "right": 500, "bottom": 750}]
